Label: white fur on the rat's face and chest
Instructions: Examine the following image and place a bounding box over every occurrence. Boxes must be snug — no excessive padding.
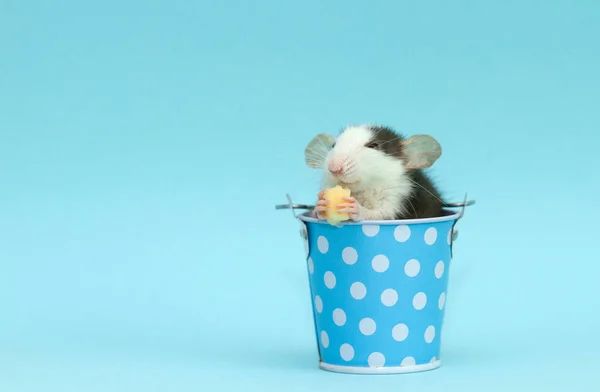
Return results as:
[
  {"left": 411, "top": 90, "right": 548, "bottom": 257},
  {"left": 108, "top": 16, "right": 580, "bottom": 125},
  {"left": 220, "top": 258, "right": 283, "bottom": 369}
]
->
[{"left": 321, "top": 125, "right": 413, "bottom": 220}]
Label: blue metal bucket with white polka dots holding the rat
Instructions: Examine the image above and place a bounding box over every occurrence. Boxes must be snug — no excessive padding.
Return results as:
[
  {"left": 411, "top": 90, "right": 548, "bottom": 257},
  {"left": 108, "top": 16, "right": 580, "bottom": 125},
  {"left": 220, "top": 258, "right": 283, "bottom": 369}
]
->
[{"left": 278, "top": 196, "right": 468, "bottom": 374}]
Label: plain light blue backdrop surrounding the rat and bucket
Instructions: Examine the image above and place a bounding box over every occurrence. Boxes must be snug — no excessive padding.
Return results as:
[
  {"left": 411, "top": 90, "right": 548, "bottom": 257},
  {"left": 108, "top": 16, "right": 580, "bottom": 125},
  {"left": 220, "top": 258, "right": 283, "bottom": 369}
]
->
[{"left": 0, "top": 0, "right": 600, "bottom": 392}]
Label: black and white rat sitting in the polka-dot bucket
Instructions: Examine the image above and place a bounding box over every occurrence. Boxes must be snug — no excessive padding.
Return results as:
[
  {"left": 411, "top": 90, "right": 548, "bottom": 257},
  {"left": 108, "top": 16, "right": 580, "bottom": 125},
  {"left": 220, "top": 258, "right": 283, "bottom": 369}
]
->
[{"left": 305, "top": 125, "right": 444, "bottom": 221}]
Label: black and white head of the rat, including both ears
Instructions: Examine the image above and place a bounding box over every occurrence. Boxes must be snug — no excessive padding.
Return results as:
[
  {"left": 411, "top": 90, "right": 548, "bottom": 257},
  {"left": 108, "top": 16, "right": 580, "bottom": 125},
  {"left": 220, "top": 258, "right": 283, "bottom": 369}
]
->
[{"left": 305, "top": 125, "right": 441, "bottom": 186}]
